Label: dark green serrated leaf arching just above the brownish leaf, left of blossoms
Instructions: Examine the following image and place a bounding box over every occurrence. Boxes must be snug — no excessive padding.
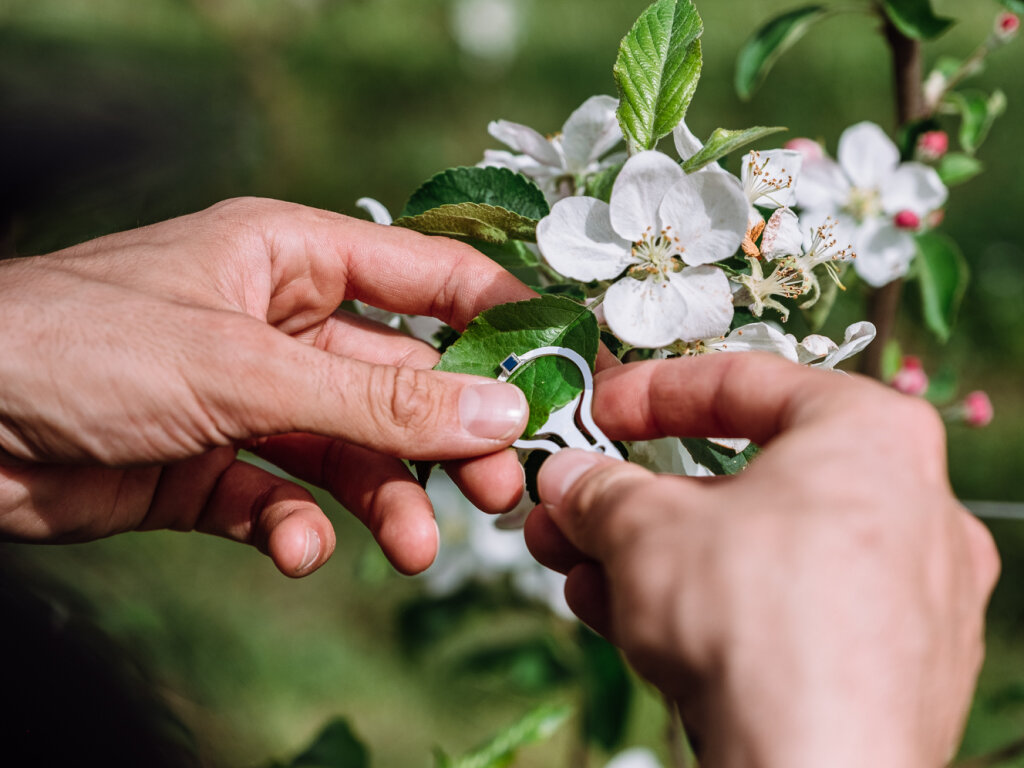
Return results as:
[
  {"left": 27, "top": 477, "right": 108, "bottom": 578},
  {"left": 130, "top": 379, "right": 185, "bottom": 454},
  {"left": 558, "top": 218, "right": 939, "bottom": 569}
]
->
[{"left": 400, "top": 167, "right": 551, "bottom": 221}]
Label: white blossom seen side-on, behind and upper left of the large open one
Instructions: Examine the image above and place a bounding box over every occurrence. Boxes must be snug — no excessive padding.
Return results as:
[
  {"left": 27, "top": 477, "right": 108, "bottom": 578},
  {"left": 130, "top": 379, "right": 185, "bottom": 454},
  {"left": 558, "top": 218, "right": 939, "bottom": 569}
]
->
[{"left": 480, "top": 96, "right": 625, "bottom": 202}]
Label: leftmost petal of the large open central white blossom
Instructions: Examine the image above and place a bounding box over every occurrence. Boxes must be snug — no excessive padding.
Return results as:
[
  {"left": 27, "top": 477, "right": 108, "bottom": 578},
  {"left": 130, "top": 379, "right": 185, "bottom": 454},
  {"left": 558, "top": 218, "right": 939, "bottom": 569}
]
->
[{"left": 537, "top": 198, "right": 636, "bottom": 283}]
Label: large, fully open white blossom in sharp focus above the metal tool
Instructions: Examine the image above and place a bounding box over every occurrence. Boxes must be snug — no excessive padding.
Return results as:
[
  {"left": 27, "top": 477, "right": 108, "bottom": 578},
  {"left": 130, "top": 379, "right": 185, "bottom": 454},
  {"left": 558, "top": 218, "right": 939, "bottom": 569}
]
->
[{"left": 537, "top": 152, "right": 748, "bottom": 347}]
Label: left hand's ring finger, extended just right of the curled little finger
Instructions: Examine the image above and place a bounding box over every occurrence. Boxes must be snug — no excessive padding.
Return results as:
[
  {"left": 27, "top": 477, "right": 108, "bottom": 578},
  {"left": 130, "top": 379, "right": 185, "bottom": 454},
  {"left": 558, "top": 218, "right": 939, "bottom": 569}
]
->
[{"left": 255, "top": 434, "right": 438, "bottom": 574}]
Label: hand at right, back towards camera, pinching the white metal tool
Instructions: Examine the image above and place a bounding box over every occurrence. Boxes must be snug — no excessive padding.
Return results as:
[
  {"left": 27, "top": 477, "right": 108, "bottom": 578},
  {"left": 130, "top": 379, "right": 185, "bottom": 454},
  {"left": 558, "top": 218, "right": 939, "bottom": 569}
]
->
[{"left": 526, "top": 354, "right": 998, "bottom": 768}]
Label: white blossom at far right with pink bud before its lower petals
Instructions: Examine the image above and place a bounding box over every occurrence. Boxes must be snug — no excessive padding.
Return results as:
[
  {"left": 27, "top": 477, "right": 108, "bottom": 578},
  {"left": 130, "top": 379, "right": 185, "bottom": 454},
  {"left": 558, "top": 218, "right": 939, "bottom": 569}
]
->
[{"left": 797, "top": 123, "right": 948, "bottom": 287}]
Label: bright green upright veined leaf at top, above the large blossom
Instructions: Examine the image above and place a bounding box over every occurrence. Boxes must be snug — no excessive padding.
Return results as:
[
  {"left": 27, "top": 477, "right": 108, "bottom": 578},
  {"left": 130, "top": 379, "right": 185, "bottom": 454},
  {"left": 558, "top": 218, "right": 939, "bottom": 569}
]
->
[{"left": 613, "top": 0, "right": 703, "bottom": 152}]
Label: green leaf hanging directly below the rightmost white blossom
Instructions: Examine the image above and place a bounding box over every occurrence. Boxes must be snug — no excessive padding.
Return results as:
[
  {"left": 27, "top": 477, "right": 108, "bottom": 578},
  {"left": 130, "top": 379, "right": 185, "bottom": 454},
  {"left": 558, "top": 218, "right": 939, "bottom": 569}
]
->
[{"left": 914, "top": 232, "right": 970, "bottom": 342}]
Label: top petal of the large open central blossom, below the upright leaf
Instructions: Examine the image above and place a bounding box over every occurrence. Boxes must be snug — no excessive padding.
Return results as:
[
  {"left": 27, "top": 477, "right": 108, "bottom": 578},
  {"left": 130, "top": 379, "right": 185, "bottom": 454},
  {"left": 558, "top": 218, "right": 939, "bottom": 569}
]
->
[{"left": 610, "top": 152, "right": 686, "bottom": 243}]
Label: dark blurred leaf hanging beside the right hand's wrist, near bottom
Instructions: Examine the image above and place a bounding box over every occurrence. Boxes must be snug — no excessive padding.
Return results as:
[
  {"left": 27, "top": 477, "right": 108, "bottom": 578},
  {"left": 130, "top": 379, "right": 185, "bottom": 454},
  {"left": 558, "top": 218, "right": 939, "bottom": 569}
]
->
[{"left": 578, "top": 625, "right": 633, "bottom": 752}]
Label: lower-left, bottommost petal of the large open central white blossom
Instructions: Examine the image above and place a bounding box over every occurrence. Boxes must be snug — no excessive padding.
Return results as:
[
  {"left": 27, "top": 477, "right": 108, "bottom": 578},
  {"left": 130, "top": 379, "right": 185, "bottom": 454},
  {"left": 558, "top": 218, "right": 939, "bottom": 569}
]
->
[{"left": 604, "top": 278, "right": 692, "bottom": 348}]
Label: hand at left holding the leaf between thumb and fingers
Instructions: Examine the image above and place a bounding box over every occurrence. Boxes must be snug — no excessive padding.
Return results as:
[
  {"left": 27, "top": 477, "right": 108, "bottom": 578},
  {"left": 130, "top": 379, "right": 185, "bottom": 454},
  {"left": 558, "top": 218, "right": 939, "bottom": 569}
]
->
[{"left": 0, "top": 200, "right": 534, "bottom": 575}]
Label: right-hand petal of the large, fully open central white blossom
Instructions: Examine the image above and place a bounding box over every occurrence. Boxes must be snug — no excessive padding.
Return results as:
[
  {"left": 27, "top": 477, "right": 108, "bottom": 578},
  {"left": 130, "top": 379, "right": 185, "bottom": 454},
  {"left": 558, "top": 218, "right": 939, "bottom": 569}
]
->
[{"left": 659, "top": 173, "right": 750, "bottom": 266}]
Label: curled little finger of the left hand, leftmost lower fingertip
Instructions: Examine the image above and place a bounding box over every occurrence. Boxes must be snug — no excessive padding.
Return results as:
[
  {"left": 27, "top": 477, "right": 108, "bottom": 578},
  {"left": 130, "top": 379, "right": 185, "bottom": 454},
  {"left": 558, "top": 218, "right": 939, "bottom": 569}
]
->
[{"left": 195, "top": 461, "right": 335, "bottom": 577}]
